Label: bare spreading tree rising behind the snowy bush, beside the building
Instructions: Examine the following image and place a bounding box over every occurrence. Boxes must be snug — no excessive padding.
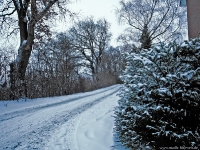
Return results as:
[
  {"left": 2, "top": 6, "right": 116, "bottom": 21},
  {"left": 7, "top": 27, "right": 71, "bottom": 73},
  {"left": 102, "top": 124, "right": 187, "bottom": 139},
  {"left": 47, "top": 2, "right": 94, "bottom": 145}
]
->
[{"left": 116, "top": 0, "right": 186, "bottom": 48}]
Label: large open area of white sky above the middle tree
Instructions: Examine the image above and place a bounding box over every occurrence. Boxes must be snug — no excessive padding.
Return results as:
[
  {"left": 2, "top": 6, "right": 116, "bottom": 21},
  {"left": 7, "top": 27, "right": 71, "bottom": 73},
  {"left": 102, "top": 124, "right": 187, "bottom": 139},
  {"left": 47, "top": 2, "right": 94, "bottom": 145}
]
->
[{"left": 55, "top": 0, "right": 123, "bottom": 46}]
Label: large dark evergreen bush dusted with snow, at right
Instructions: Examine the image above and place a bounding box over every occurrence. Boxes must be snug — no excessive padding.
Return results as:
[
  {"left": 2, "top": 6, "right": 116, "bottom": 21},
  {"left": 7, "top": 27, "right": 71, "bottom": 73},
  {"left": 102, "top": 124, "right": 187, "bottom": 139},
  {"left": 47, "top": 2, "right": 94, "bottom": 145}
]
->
[{"left": 115, "top": 39, "right": 200, "bottom": 149}]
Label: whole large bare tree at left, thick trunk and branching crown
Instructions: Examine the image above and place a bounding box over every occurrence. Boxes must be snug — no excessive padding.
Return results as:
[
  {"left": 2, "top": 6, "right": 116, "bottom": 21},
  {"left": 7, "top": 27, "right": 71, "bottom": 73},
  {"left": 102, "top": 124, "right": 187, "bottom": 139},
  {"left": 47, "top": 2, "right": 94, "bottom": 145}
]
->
[{"left": 0, "top": 0, "right": 75, "bottom": 99}]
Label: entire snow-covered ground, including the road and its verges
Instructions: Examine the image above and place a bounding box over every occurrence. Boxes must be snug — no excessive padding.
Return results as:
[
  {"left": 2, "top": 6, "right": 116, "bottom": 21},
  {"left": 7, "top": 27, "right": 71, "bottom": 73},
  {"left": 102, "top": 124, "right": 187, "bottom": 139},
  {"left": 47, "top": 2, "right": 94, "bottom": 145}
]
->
[{"left": 0, "top": 85, "right": 129, "bottom": 150}]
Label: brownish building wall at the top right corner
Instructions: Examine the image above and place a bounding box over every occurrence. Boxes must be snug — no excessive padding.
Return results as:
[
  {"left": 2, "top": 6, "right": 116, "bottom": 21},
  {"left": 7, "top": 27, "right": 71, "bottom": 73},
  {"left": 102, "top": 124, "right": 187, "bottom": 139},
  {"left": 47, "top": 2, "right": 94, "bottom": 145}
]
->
[{"left": 187, "top": 0, "right": 200, "bottom": 39}]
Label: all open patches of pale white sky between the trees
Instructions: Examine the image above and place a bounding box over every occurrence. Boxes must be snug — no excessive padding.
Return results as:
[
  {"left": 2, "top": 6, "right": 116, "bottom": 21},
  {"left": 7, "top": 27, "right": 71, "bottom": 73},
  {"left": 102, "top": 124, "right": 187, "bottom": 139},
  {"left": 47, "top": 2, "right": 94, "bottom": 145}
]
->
[{"left": 0, "top": 0, "right": 124, "bottom": 49}]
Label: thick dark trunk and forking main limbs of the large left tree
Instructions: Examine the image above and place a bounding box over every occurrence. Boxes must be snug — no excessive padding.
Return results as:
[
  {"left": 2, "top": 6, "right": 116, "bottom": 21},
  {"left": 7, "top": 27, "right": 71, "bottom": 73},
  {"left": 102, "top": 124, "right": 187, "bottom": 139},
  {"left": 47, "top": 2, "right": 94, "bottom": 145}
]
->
[{"left": 10, "top": 0, "right": 58, "bottom": 99}]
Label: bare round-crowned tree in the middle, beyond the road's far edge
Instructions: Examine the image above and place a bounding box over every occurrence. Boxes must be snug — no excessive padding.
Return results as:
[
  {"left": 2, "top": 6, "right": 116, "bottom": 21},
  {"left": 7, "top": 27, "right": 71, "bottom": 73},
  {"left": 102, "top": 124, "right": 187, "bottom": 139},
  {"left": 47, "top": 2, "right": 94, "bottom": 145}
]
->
[{"left": 69, "top": 18, "right": 111, "bottom": 81}]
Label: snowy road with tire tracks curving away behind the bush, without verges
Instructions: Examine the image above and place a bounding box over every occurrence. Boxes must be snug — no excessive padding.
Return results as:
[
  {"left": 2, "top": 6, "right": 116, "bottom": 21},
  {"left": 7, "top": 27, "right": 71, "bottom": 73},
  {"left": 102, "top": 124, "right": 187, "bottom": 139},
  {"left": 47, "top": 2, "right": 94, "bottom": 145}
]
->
[{"left": 0, "top": 85, "right": 120, "bottom": 150}]
